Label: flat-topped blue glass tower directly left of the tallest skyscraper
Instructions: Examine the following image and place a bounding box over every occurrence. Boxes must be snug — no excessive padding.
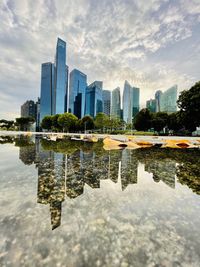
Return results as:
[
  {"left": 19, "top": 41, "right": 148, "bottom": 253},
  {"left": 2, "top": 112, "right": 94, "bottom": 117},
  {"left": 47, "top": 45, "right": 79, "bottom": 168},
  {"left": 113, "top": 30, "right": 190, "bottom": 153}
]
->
[{"left": 40, "top": 62, "right": 54, "bottom": 122}]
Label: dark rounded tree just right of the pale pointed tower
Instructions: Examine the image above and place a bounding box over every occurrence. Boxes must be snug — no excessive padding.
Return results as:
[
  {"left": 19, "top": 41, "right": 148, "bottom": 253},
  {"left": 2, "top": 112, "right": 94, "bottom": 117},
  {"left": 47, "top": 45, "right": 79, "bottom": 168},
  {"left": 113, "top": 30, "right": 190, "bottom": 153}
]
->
[{"left": 133, "top": 108, "right": 152, "bottom": 131}]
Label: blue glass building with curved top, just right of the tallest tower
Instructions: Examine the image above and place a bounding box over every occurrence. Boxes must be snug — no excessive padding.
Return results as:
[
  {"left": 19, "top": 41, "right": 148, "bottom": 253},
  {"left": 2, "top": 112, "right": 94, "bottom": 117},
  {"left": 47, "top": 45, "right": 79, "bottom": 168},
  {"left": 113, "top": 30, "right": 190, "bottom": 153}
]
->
[{"left": 69, "top": 69, "right": 87, "bottom": 119}]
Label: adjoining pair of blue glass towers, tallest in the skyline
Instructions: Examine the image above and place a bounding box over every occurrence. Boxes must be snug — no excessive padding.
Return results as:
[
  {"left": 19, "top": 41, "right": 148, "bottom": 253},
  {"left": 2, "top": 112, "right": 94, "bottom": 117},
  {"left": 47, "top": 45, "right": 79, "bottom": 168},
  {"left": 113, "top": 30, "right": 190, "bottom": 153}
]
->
[{"left": 40, "top": 38, "right": 68, "bottom": 123}]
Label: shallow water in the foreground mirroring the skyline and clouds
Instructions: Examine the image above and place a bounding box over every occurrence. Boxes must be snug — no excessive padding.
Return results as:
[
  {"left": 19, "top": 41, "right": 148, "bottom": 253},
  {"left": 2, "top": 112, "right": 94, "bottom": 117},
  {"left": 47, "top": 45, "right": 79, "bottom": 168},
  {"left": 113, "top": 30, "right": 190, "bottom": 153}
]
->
[{"left": 0, "top": 137, "right": 200, "bottom": 267}]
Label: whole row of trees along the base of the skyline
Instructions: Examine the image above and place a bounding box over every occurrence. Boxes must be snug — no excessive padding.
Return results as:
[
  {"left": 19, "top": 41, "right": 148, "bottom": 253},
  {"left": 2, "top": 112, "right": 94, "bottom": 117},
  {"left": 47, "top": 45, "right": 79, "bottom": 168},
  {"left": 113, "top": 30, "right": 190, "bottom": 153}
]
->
[{"left": 0, "top": 82, "right": 200, "bottom": 134}]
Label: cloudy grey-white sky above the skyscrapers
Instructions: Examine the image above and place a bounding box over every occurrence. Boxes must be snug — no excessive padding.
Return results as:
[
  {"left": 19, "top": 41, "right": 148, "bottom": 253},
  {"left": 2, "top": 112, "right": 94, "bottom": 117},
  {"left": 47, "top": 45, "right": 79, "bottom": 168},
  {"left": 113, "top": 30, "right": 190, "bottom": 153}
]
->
[{"left": 0, "top": 0, "right": 200, "bottom": 119}]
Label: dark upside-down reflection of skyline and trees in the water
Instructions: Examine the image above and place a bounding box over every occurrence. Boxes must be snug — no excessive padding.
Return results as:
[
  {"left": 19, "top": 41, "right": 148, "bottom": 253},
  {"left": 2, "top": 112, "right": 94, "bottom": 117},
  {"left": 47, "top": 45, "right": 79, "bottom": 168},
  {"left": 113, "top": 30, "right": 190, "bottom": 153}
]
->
[{"left": 14, "top": 139, "right": 199, "bottom": 229}]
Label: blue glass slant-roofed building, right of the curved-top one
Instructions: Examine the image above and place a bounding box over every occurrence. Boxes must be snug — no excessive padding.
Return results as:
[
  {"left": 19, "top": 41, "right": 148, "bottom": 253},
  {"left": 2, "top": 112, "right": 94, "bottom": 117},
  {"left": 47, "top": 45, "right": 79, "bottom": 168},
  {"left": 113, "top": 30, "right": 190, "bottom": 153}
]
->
[{"left": 85, "top": 81, "right": 103, "bottom": 118}]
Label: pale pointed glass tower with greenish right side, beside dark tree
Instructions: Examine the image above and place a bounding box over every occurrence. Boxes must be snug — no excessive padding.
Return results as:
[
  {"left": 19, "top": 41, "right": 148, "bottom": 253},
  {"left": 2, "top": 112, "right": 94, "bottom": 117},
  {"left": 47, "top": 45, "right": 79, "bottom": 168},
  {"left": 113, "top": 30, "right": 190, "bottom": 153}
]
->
[{"left": 123, "top": 81, "right": 140, "bottom": 123}]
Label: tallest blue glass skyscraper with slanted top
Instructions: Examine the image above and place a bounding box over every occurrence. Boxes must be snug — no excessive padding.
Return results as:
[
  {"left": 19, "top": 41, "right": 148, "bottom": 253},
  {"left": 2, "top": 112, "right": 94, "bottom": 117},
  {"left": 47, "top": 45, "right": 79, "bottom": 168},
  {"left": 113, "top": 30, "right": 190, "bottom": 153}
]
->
[{"left": 53, "top": 38, "right": 68, "bottom": 114}]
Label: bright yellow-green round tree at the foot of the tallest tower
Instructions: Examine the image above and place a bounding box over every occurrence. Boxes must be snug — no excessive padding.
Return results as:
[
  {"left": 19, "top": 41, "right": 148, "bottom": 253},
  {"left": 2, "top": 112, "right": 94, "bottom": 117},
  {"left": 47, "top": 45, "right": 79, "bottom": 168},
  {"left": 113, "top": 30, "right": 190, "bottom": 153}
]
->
[{"left": 58, "top": 112, "right": 78, "bottom": 132}]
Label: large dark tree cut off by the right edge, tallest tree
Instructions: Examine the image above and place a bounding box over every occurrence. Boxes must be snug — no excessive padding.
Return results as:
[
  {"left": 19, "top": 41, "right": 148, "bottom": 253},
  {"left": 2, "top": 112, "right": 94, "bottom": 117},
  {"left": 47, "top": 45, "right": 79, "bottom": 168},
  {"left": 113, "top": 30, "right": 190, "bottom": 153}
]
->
[{"left": 177, "top": 81, "right": 200, "bottom": 131}]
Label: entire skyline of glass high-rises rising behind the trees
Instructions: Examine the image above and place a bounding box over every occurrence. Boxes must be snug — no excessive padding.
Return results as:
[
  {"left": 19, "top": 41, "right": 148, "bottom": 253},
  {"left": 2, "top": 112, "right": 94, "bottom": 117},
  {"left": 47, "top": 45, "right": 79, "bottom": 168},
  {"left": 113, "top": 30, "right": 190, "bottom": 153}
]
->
[{"left": 21, "top": 38, "right": 177, "bottom": 128}]
